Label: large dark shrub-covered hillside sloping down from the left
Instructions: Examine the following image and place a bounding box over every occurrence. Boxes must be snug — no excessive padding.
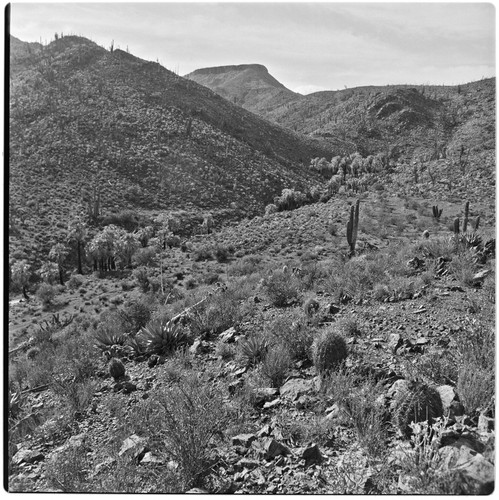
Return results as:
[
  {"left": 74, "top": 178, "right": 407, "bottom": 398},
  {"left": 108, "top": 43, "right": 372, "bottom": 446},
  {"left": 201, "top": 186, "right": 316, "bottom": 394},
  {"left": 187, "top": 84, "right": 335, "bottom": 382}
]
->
[{"left": 9, "top": 36, "right": 330, "bottom": 262}]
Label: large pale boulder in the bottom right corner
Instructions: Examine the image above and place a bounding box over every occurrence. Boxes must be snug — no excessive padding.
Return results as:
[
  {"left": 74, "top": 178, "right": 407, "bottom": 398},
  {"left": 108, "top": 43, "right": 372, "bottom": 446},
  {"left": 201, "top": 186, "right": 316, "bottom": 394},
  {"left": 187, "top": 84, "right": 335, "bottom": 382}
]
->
[{"left": 437, "top": 446, "right": 494, "bottom": 494}]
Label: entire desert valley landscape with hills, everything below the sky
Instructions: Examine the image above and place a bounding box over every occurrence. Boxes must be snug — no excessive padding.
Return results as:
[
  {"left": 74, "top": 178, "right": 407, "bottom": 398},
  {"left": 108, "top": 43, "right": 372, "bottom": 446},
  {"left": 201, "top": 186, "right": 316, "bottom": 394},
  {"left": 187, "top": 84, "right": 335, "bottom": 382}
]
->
[{"left": 4, "top": 35, "right": 496, "bottom": 495}]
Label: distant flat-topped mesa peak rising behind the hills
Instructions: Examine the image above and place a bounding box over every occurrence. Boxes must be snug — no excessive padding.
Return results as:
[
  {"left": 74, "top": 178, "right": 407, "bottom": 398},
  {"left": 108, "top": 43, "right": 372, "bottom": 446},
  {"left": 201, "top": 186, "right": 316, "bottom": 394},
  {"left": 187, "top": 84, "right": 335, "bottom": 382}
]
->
[{"left": 185, "top": 64, "right": 303, "bottom": 116}]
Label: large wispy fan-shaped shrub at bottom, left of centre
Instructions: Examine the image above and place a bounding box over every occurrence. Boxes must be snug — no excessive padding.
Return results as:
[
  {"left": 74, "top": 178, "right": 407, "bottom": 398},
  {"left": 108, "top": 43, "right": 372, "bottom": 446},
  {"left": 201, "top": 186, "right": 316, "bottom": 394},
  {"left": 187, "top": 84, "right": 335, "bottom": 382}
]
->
[{"left": 138, "top": 374, "right": 232, "bottom": 493}]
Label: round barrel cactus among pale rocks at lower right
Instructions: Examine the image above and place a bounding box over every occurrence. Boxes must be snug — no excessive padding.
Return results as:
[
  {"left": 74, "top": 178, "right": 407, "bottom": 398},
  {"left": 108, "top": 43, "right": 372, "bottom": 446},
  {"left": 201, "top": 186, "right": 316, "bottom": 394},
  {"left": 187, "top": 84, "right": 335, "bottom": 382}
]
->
[{"left": 393, "top": 381, "right": 444, "bottom": 438}]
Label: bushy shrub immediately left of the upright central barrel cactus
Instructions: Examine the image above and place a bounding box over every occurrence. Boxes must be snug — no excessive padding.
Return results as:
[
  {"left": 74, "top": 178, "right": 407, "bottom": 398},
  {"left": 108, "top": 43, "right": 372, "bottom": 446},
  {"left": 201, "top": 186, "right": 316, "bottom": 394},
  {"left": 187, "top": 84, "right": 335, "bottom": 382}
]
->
[{"left": 265, "top": 313, "right": 314, "bottom": 360}]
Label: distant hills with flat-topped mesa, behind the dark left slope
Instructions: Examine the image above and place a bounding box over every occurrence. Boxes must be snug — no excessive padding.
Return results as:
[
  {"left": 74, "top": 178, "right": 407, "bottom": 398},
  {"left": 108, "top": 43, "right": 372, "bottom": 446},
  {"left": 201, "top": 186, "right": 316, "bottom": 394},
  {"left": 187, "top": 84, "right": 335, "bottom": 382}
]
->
[{"left": 186, "top": 64, "right": 495, "bottom": 159}]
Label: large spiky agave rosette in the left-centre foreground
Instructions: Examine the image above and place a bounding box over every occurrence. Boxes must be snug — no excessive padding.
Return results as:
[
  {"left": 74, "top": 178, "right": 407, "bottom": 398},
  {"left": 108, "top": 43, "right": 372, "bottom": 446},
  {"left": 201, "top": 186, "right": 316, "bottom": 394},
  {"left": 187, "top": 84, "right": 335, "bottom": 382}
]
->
[{"left": 136, "top": 320, "right": 190, "bottom": 355}]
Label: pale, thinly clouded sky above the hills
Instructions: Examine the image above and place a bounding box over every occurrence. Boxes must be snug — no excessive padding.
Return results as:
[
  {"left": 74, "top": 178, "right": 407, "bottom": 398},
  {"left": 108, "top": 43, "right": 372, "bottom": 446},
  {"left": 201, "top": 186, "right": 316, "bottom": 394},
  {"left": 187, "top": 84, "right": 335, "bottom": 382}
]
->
[{"left": 10, "top": 1, "right": 495, "bottom": 94}]
